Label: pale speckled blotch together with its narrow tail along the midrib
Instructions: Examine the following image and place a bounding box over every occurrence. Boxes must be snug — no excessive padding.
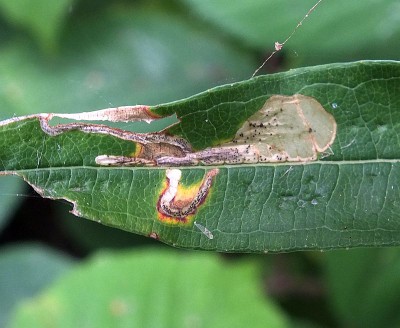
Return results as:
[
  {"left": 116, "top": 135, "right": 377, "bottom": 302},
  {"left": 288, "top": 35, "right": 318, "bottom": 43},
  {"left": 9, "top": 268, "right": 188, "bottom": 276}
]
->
[{"left": 97, "top": 95, "right": 337, "bottom": 166}]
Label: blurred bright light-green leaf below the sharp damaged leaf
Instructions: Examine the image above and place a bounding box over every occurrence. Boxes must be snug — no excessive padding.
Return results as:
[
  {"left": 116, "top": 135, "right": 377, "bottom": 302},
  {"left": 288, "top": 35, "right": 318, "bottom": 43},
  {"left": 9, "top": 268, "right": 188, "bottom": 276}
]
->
[{"left": 7, "top": 251, "right": 288, "bottom": 328}]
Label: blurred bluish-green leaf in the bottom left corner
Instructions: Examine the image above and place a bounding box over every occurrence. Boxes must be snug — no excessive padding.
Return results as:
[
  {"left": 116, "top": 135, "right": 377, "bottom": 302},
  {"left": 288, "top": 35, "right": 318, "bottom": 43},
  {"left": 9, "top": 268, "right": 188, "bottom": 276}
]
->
[{"left": 0, "top": 244, "right": 72, "bottom": 327}]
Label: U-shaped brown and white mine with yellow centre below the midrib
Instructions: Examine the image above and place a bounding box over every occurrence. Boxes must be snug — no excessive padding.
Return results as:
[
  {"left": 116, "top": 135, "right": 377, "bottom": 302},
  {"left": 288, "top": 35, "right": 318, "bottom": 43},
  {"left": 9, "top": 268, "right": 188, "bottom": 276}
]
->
[{"left": 157, "top": 169, "right": 219, "bottom": 224}]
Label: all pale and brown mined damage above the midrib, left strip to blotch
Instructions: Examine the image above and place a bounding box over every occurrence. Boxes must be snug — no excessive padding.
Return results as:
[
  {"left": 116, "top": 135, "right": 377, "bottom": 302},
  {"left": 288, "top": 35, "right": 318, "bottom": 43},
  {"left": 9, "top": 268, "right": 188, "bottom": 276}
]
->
[{"left": 0, "top": 95, "right": 337, "bottom": 167}]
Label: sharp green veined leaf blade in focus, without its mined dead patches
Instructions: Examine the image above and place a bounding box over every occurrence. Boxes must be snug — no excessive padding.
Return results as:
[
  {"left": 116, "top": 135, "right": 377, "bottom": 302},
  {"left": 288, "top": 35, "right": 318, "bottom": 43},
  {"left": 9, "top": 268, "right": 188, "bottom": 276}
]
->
[{"left": 0, "top": 62, "right": 400, "bottom": 252}]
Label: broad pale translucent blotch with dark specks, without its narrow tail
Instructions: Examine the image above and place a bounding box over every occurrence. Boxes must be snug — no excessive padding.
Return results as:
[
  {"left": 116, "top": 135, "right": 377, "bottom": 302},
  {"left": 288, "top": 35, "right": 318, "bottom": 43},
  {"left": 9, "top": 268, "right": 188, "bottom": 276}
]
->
[{"left": 224, "top": 95, "right": 336, "bottom": 162}]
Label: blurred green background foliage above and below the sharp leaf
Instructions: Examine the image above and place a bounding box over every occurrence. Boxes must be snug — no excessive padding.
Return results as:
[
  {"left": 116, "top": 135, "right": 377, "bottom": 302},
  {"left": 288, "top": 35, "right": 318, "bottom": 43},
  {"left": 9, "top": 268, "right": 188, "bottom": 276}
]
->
[{"left": 0, "top": 0, "right": 400, "bottom": 327}]
